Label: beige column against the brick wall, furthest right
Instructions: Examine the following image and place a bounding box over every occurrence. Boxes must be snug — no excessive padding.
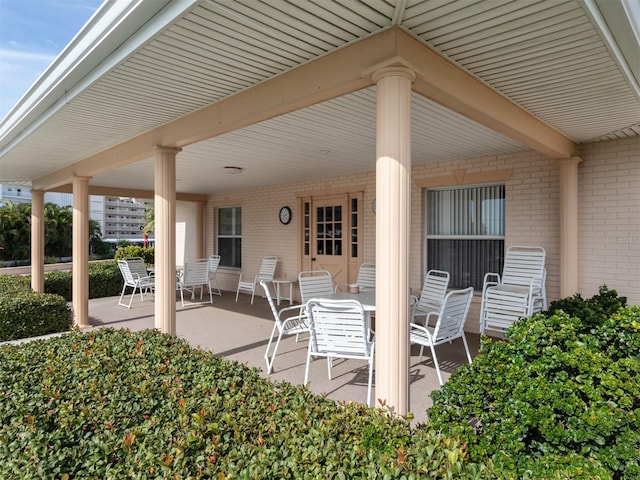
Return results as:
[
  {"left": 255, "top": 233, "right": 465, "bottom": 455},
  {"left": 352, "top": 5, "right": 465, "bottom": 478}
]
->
[{"left": 559, "top": 157, "right": 582, "bottom": 298}]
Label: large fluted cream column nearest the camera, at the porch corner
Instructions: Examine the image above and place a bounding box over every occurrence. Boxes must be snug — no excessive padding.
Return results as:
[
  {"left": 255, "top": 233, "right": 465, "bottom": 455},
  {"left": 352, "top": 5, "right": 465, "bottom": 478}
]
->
[{"left": 372, "top": 66, "right": 415, "bottom": 415}]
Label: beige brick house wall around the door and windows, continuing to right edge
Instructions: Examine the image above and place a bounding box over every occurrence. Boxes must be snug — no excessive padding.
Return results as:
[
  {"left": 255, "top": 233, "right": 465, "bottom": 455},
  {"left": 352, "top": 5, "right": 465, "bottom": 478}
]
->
[{"left": 188, "top": 139, "right": 640, "bottom": 331}]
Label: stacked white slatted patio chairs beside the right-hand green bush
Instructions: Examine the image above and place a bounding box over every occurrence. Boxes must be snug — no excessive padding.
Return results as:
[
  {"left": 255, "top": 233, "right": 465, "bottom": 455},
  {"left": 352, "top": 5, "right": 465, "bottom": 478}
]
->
[{"left": 480, "top": 245, "right": 547, "bottom": 334}]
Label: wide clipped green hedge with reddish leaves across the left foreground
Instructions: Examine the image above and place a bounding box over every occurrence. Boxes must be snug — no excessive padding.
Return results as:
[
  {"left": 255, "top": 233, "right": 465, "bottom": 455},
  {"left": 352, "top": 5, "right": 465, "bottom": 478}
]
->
[{"left": 0, "top": 329, "right": 492, "bottom": 480}]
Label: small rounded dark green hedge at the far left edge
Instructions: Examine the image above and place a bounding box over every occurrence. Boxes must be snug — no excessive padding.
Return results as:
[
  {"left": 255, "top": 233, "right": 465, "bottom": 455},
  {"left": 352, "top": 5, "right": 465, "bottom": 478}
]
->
[{"left": 0, "top": 292, "right": 71, "bottom": 342}]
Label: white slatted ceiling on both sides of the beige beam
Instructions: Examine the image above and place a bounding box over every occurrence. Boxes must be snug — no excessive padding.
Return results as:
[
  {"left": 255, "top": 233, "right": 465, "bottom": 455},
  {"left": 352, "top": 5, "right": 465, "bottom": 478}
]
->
[{"left": 0, "top": 0, "right": 640, "bottom": 193}]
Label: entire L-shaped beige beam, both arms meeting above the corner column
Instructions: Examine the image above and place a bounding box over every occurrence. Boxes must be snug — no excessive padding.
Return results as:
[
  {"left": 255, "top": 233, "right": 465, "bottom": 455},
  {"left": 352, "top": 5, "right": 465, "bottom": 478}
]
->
[{"left": 32, "top": 28, "right": 576, "bottom": 191}]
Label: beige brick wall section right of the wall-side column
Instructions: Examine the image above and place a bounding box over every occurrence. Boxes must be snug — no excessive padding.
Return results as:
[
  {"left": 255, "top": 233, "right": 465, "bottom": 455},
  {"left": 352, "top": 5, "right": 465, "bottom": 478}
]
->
[{"left": 578, "top": 138, "right": 640, "bottom": 305}]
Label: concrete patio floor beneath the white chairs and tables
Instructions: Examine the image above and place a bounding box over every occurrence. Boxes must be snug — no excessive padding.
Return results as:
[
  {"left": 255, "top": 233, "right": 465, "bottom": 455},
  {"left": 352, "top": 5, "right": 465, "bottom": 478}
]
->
[{"left": 89, "top": 292, "right": 480, "bottom": 424}]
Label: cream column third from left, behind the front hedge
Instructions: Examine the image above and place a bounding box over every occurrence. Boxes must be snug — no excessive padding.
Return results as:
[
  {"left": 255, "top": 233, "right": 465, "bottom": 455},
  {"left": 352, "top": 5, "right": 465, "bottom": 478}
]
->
[{"left": 154, "top": 146, "right": 181, "bottom": 335}]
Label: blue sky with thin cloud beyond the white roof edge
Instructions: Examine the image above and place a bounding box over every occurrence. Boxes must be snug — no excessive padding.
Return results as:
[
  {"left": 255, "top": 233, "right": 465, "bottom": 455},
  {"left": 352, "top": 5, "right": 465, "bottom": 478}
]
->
[{"left": 0, "top": 0, "right": 103, "bottom": 119}]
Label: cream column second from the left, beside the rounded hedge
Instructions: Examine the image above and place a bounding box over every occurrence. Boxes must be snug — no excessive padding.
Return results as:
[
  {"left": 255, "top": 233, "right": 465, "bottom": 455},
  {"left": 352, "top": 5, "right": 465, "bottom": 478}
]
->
[{"left": 72, "top": 177, "right": 91, "bottom": 328}]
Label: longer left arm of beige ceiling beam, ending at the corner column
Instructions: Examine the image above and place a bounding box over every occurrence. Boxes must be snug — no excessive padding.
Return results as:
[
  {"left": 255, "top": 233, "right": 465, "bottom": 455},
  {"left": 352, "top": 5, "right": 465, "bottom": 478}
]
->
[{"left": 32, "top": 30, "right": 395, "bottom": 190}]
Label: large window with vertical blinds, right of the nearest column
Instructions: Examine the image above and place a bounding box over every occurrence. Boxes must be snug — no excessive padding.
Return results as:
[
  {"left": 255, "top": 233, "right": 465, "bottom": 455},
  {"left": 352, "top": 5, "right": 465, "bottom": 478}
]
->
[{"left": 424, "top": 185, "right": 505, "bottom": 290}]
